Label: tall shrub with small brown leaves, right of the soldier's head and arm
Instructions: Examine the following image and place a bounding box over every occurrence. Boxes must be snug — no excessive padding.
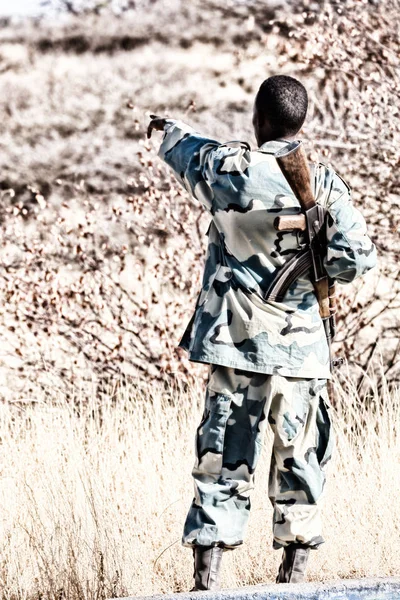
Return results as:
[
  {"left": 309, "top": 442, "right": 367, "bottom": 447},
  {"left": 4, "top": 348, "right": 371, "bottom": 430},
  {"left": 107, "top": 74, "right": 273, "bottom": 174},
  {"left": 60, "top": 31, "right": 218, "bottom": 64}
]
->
[{"left": 277, "top": 0, "right": 400, "bottom": 385}]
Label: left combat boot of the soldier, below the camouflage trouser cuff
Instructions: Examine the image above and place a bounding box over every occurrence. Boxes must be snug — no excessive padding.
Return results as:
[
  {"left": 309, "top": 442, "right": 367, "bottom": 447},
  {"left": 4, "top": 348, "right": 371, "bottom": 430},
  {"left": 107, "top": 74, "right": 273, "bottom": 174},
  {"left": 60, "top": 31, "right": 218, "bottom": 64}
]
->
[{"left": 190, "top": 546, "right": 224, "bottom": 592}]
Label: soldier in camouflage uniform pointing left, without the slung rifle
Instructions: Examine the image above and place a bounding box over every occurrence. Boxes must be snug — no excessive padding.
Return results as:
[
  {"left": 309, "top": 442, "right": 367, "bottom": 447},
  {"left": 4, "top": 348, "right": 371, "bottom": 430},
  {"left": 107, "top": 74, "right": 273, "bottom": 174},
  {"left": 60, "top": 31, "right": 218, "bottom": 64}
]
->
[{"left": 148, "top": 75, "right": 376, "bottom": 590}]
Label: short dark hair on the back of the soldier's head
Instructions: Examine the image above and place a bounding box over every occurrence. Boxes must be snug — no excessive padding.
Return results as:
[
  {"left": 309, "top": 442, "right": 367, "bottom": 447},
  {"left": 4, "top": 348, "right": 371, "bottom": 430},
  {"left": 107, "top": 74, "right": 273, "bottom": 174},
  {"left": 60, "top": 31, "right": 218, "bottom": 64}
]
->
[{"left": 255, "top": 75, "right": 308, "bottom": 136}]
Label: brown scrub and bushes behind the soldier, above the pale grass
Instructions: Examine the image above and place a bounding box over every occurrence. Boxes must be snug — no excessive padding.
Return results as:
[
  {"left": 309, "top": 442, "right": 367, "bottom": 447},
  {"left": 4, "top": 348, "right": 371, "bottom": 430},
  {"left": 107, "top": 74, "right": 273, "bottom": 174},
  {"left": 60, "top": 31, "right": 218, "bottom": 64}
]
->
[{"left": 0, "top": 0, "right": 400, "bottom": 396}]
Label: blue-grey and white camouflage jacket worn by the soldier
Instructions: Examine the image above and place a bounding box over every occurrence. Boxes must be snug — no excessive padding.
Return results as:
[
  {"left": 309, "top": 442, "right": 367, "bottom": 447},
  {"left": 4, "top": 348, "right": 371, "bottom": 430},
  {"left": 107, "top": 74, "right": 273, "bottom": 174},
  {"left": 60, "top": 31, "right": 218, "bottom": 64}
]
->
[{"left": 159, "top": 119, "right": 376, "bottom": 378}]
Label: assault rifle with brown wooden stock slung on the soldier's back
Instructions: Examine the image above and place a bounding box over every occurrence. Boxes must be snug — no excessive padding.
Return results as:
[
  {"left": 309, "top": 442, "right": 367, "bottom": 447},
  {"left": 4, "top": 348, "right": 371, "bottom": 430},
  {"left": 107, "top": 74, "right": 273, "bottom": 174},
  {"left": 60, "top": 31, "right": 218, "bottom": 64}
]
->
[{"left": 264, "top": 141, "right": 343, "bottom": 367}]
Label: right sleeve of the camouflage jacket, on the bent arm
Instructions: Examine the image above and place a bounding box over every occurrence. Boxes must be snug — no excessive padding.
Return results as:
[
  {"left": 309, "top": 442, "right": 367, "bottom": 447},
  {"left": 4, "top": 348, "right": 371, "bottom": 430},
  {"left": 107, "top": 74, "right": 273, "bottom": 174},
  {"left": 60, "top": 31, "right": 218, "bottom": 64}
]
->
[{"left": 325, "top": 174, "right": 376, "bottom": 283}]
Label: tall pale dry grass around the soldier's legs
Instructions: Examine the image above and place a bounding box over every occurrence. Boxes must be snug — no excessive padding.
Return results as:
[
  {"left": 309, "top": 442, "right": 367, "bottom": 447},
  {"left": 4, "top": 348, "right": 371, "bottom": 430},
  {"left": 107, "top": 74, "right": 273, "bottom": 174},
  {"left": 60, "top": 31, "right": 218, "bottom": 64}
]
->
[{"left": 0, "top": 366, "right": 400, "bottom": 600}]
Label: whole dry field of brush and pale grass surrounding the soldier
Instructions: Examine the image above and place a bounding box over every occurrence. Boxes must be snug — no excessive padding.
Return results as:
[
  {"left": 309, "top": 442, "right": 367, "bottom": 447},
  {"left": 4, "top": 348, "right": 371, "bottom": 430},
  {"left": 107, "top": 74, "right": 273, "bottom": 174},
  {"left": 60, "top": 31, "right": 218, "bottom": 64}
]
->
[{"left": 0, "top": 0, "right": 400, "bottom": 600}]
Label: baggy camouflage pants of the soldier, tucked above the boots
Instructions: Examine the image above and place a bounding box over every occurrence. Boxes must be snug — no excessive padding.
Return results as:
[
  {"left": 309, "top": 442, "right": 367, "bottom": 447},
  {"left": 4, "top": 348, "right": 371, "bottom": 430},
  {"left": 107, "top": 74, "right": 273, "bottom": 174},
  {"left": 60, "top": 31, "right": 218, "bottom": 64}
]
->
[{"left": 182, "top": 365, "right": 333, "bottom": 548}]
